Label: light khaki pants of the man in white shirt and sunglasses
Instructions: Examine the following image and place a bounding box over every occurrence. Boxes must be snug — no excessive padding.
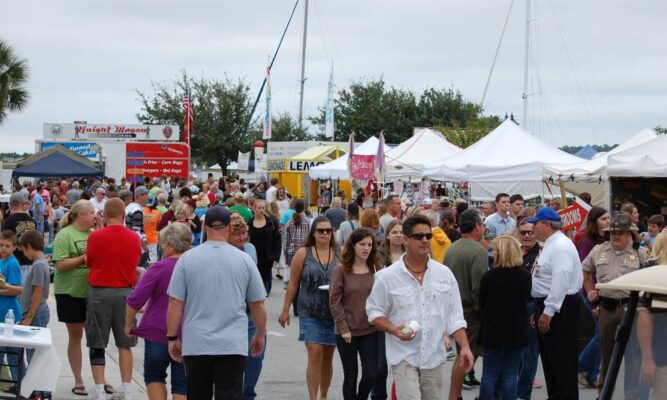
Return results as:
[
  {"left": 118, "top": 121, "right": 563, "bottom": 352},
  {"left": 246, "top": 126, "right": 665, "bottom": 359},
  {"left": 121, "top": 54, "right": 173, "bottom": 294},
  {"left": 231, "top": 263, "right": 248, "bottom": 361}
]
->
[{"left": 391, "top": 361, "right": 445, "bottom": 400}]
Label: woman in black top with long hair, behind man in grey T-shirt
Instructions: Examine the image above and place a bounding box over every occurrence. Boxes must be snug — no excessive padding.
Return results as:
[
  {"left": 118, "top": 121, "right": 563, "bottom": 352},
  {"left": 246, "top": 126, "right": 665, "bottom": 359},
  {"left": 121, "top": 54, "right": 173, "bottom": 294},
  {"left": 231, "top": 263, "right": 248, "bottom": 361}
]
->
[{"left": 248, "top": 199, "right": 282, "bottom": 296}]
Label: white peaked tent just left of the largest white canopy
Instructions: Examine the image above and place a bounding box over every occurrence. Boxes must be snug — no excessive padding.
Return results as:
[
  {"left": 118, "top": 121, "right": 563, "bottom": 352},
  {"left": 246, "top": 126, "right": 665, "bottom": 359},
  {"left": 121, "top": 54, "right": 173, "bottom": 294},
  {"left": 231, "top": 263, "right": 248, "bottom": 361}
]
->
[{"left": 385, "top": 128, "right": 461, "bottom": 182}]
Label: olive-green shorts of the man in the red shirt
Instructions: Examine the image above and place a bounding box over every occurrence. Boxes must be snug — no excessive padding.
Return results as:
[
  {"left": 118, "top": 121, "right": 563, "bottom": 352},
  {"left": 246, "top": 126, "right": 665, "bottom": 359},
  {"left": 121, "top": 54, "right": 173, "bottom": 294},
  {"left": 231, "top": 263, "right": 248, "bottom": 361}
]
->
[{"left": 86, "top": 287, "right": 137, "bottom": 349}]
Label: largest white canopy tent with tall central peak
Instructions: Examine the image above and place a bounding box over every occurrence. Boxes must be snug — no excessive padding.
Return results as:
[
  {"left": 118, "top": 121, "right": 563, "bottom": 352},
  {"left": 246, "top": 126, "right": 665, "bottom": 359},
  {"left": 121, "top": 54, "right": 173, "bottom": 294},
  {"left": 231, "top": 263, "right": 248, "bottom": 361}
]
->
[{"left": 423, "top": 119, "right": 582, "bottom": 200}]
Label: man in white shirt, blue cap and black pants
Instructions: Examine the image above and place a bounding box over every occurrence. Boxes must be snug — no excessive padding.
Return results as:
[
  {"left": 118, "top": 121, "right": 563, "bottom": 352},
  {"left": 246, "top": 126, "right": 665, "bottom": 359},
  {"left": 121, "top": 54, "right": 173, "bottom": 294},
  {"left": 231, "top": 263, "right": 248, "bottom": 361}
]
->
[{"left": 528, "top": 207, "right": 584, "bottom": 399}]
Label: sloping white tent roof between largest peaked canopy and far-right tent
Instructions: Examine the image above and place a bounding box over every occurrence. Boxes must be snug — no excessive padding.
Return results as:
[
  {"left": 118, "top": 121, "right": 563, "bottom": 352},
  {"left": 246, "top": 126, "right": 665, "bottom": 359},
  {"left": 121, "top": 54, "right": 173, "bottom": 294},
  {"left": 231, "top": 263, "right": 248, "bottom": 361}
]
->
[{"left": 544, "top": 129, "right": 657, "bottom": 182}]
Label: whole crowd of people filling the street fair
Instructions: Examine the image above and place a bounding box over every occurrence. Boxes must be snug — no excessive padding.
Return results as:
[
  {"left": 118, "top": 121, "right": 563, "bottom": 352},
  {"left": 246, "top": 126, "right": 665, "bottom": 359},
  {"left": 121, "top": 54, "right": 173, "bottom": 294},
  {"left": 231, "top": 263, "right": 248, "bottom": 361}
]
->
[{"left": 0, "top": 176, "right": 667, "bottom": 400}]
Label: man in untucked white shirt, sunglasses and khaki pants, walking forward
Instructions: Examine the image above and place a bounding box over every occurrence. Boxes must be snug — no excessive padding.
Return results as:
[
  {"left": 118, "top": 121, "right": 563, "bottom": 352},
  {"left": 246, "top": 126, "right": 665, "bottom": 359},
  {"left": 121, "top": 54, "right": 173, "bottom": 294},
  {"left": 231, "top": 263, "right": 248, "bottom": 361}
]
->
[{"left": 366, "top": 215, "right": 474, "bottom": 400}]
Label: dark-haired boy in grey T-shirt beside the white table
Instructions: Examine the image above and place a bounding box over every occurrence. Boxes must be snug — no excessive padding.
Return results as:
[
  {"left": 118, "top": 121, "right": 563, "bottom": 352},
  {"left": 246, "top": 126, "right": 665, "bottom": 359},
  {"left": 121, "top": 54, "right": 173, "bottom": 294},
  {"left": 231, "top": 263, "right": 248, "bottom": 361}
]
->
[{"left": 19, "top": 231, "right": 51, "bottom": 399}]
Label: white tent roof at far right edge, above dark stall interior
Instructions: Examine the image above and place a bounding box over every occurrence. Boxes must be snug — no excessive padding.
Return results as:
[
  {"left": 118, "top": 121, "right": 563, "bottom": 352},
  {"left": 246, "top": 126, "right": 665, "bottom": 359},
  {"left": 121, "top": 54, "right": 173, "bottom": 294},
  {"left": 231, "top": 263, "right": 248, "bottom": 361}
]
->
[{"left": 607, "top": 135, "right": 667, "bottom": 178}]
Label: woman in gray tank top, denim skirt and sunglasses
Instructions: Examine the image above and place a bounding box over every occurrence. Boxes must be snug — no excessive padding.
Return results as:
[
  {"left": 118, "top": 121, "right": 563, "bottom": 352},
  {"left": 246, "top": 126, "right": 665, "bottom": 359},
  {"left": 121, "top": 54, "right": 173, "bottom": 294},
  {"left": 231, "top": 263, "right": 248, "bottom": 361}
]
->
[{"left": 278, "top": 216, "right": 339, "bottom": 400}]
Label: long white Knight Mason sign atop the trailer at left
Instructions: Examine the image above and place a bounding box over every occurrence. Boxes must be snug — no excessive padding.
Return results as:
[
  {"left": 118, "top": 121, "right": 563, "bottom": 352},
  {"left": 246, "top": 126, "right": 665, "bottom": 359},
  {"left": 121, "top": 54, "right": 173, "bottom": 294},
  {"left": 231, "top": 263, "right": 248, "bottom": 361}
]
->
[{"left": 43, "top": 123, "right": 180, "bottom": 142}]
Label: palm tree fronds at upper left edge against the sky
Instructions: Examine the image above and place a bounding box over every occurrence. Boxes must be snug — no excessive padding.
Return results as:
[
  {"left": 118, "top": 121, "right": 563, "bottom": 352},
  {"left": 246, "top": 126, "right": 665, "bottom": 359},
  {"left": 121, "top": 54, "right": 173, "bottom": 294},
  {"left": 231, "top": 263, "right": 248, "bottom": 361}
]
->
[{"left": 0, "top": 40, "right": 30, "bottom": 124}]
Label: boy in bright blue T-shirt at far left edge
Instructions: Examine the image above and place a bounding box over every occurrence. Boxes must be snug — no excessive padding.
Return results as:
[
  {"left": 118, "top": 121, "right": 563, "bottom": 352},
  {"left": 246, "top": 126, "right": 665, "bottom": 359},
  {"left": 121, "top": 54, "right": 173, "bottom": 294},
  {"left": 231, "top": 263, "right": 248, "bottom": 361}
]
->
[{"left": 0, "top": 230, "right": 23, "bottom": 391}]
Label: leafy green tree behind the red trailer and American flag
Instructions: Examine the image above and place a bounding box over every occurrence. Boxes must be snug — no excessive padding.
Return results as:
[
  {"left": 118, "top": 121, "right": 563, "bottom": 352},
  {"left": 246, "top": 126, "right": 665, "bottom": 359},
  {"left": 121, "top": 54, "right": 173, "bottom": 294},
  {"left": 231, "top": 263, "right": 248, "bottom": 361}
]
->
[{"left": 137, "top": 71, "right": 260, "bottom": 174}]
